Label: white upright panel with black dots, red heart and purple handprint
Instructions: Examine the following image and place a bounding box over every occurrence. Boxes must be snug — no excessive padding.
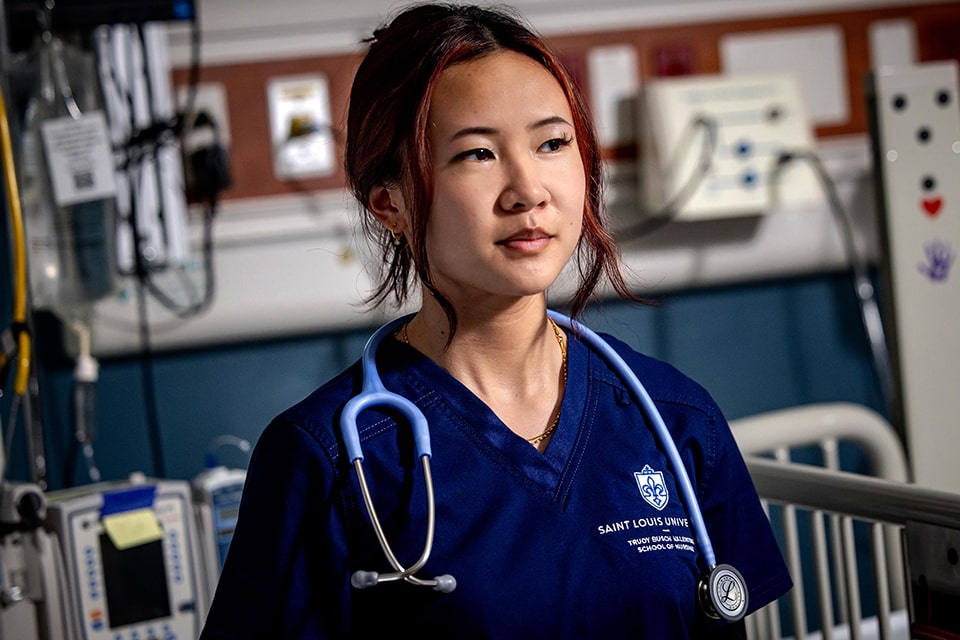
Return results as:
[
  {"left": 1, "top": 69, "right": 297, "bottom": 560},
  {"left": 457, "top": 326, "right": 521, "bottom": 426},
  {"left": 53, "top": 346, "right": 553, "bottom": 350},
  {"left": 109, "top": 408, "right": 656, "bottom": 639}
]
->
[{"left": 867, "top": 61, "right": 960, "bottom": 490}]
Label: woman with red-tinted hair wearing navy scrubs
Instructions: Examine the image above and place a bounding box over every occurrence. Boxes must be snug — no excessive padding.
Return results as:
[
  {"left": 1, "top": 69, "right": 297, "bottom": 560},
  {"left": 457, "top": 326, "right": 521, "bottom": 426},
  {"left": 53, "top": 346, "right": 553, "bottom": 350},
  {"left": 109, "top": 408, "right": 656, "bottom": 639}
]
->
[{"left": 204, "top": 5, "right": 790, "bottom": 640}]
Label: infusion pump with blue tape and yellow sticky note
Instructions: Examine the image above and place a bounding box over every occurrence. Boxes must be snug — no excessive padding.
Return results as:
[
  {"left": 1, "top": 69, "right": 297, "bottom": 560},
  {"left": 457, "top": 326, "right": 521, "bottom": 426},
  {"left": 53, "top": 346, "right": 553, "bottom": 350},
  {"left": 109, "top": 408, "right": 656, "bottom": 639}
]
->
[{"left": 46, "top": 476, "right": 207, "bottom": 640}]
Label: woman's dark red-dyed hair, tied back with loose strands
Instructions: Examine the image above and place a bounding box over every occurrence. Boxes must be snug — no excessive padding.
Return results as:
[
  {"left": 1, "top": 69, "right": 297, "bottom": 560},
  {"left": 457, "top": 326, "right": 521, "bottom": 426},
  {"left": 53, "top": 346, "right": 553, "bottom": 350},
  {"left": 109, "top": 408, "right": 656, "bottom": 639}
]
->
[{"left": 345, "top": 4, "right": 636, "bottom": 335}]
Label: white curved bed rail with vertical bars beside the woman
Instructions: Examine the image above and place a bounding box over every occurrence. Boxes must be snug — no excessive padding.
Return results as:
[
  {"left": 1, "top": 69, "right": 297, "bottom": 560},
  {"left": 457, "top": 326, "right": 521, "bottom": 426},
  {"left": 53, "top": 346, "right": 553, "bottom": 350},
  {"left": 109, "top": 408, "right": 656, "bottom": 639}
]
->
[{"left": 731, "top": 403, "right": 924, "bottom": 640}]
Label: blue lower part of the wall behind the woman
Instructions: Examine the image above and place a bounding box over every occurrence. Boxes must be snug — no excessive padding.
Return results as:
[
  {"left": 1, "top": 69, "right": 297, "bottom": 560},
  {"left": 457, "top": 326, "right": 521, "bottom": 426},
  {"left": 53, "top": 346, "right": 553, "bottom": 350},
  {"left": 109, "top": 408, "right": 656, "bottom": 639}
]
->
[{"left": 0, "top": 245, "right": 886, "bottom": 488}]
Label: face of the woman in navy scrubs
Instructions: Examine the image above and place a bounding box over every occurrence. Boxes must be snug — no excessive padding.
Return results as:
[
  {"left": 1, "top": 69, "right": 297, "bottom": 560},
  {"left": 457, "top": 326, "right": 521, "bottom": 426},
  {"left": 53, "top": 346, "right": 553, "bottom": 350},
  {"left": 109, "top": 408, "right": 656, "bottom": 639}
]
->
[{"left": 426, "top": 51, "right": 586, "bottom": 305}]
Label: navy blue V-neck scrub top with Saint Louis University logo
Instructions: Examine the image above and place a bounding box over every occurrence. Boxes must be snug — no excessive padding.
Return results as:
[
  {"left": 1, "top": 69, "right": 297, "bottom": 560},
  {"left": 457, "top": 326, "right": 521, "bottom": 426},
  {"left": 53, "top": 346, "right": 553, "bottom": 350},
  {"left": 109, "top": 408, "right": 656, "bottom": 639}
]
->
[{"left": 203, "top": 328, "right": 791, "bottom": 640}]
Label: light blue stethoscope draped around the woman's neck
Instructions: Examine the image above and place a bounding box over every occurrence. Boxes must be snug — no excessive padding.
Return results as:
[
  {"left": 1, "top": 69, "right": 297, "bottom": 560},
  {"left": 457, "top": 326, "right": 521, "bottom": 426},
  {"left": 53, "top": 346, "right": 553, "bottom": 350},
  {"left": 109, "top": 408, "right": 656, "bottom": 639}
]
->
[{"left": 340, "top": 310, "right": 747, "bottom": 621}]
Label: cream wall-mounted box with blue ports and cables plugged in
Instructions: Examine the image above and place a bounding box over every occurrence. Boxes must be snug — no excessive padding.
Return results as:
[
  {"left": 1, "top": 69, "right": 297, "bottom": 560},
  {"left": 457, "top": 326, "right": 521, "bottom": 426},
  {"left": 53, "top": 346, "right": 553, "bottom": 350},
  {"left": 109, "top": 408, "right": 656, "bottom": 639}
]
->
[{"left": 639, "top": 75, "right": 823, "bottom": 220}]
